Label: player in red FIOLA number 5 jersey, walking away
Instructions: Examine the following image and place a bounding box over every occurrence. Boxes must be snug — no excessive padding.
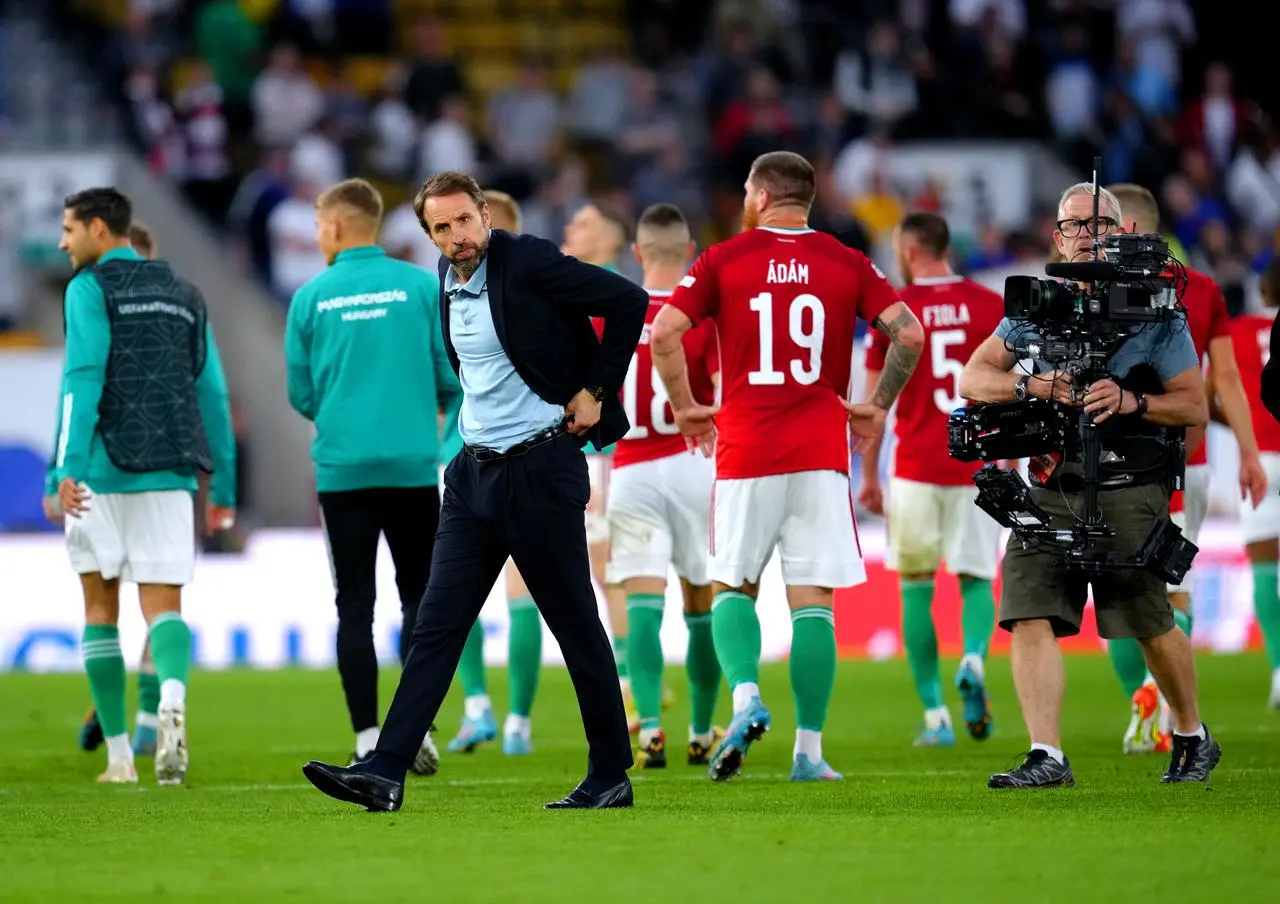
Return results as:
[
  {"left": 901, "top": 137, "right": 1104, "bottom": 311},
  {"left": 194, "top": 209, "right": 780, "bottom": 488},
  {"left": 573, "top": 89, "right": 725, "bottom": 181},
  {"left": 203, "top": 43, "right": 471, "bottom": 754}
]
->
[{"left": 859, "top": 213, "right": 1005, "bottom": 747}]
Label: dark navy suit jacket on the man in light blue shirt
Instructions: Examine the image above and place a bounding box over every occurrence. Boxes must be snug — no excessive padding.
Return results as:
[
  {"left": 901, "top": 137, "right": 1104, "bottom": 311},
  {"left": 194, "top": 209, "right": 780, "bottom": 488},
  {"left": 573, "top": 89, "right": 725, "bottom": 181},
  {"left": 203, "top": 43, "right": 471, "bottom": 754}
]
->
[{"left": 439, "top": 229, "right": 649, "bottom": 449}]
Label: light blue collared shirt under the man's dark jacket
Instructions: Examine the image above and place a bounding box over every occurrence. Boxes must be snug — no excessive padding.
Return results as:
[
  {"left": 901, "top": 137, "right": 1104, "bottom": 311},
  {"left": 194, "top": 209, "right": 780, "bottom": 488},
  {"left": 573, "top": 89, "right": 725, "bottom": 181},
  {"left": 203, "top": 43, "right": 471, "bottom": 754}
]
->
[{"left": 444, "top": 253, "right": 564, "bottom": 452}]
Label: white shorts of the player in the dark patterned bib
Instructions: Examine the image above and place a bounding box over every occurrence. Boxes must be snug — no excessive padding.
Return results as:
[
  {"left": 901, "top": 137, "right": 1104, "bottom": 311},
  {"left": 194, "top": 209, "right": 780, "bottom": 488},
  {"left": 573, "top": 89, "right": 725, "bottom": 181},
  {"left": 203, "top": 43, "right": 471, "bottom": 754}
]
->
[{"left": 64, "top": 488, "right": 196, "bottom": 586}]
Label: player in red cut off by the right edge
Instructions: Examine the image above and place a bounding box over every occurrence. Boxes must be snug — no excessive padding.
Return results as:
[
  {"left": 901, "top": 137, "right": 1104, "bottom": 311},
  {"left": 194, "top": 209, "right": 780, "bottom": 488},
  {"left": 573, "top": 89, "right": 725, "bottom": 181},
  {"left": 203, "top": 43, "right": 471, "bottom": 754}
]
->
[{"left": 1215, "top": 260, "right": 1280, "bottom": 709}]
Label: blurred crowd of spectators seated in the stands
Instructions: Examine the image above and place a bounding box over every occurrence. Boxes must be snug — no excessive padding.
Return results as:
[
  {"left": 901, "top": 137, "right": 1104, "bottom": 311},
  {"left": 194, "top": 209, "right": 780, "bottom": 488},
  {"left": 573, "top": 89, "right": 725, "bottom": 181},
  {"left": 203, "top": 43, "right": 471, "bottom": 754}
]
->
[{"left": 12, "top": 0, "right": 1280, "bottom": 309}]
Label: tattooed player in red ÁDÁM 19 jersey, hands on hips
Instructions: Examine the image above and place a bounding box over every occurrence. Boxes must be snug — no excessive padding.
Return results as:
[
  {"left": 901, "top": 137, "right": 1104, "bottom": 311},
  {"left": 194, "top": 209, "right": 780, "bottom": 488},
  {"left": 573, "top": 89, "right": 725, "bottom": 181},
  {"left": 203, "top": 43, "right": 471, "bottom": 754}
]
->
[{"left": 653, "top": 151, "right": 924, "bottom": 781}]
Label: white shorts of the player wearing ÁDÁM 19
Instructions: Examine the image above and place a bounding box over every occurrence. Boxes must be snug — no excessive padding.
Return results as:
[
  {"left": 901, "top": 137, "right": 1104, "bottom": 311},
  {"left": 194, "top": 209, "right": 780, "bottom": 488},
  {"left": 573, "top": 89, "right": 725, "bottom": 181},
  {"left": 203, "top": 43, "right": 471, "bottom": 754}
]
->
[{"left": 710, "top": 471, "right": 867, "bottom": 588}]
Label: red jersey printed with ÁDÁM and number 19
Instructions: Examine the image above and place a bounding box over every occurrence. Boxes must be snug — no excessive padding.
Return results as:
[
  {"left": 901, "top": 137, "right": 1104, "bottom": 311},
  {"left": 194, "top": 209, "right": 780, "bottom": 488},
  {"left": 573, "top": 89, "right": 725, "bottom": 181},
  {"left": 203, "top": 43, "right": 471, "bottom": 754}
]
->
[{"left": 671, "top": 227, "right": 897, "bottom": 478}]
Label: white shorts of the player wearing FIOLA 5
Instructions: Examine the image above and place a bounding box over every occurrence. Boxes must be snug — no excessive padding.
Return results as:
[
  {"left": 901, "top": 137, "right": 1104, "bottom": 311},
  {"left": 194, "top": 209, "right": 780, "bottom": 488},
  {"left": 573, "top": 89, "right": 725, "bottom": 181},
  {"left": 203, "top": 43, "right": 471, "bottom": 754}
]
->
[{"left": 884, "top": 478, "right": 1000, "bottom": 580}]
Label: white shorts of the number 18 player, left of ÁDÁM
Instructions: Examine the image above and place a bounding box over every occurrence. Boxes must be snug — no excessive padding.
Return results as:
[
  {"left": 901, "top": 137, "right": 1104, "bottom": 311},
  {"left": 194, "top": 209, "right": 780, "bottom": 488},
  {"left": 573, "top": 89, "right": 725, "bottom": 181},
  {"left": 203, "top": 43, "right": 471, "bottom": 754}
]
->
[{"left": 605, "top": 453, "right": 716, "bottom": 586}]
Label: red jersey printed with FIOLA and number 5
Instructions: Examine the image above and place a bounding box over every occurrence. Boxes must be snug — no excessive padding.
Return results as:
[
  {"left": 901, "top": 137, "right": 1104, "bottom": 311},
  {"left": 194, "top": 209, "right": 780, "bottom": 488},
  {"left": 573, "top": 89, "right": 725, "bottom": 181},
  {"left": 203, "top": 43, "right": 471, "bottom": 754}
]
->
[{"left": 867, "top": 277, "right": 1005, "bottom": 487}]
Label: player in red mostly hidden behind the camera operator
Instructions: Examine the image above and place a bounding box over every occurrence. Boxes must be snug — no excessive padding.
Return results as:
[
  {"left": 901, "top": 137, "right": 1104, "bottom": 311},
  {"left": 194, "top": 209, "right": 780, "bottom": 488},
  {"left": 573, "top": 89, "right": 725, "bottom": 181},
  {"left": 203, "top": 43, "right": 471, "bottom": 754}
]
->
[{"left": 1107, "top": 184, "right": 1267, "bottom": 753}]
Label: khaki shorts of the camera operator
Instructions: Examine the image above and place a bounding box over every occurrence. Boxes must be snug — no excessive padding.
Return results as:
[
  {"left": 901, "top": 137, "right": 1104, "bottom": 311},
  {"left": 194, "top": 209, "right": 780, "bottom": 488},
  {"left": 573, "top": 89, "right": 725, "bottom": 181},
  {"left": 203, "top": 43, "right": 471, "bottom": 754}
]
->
[{"left": 1000, "top": 484, "right": 1174, "bottom": 640}]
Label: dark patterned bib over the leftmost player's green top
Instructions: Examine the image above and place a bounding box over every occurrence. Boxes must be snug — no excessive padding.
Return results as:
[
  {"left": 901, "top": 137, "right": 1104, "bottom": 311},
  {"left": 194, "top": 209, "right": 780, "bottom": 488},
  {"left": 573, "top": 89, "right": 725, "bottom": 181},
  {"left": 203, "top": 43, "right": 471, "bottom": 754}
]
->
[{"left": 73, "top": 259, "right": 214, "bottom": 472}]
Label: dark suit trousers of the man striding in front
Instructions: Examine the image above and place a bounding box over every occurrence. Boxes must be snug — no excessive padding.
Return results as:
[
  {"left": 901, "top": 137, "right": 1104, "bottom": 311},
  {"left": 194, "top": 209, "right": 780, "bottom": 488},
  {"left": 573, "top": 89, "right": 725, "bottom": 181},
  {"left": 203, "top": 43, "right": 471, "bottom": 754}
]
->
[{"left": 378, "top": 434, "right": 632, "bottom": 780}]
